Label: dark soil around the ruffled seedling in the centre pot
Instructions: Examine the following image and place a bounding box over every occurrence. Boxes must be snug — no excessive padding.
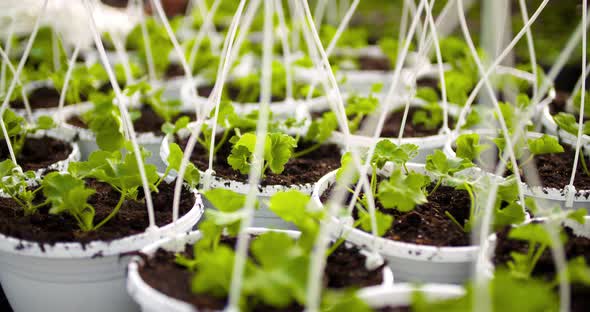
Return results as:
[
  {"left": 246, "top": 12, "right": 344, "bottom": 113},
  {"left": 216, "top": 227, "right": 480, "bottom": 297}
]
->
[{"left": 179, "top": 137, "right": 340, "bottom": 186}]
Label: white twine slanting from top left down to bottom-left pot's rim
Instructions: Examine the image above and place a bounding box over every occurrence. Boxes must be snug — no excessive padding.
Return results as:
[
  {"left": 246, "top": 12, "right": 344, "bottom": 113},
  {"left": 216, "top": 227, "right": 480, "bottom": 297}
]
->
[{"left": 84, "top": 0, "right": 158, "bottom": 231}]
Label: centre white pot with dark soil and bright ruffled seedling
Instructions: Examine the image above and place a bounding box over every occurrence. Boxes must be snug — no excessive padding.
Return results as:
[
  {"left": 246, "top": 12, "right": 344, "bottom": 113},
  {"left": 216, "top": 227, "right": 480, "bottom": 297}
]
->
[{"left": 160, "top": 116, "right": 341, "bottom": 229}]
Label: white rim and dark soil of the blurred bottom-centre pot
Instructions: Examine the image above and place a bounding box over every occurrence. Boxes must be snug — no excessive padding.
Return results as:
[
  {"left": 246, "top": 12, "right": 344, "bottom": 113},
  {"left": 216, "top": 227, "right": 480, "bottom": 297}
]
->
[{"left": 127, "top": 228, "right": 393, "bottom": 311}]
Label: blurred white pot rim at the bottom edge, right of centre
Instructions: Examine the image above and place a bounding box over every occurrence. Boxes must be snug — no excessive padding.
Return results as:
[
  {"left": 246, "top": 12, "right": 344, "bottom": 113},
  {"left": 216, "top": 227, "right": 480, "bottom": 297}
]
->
[{"left": 359, "top": 283, "right": 465, "bottom": 308}]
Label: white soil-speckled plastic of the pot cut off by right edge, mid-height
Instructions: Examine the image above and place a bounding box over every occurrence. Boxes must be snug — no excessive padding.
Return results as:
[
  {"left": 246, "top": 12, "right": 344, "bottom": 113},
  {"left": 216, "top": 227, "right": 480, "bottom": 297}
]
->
[{"left": 444, "top": 130, "right": 590, "bottom": 211}]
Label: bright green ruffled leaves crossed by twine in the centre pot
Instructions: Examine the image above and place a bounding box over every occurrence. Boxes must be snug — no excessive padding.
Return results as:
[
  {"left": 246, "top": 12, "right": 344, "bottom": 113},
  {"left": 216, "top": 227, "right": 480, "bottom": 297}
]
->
[{"left": 227, "top": 133, "right": 297, "bottom": 174}]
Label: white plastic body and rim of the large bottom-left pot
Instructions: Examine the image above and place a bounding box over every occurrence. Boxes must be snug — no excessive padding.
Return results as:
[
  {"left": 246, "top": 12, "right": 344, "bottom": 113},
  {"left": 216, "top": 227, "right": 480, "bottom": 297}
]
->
[{"left": 0, "top": 191, "right": 203, "bottom": 312}]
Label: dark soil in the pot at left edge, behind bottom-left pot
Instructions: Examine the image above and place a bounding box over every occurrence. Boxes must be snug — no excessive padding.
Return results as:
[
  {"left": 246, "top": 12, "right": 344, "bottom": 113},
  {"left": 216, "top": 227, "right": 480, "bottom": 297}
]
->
[{"left": 0, "top": 136, "right": 72, "bottom": 171}]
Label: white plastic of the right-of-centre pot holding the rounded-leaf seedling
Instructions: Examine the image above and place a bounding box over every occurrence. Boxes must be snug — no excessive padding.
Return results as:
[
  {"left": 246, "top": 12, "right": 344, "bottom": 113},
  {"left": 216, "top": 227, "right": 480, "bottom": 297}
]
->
[{"left": 313, "top": 163, "right": 479, "bottom": 283}]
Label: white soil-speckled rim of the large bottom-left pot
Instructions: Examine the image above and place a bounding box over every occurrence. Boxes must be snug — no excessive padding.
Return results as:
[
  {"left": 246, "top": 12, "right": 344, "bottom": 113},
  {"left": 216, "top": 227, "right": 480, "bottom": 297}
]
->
[{"left": 0, "top": 185, "right": 204, "bottom": 259}]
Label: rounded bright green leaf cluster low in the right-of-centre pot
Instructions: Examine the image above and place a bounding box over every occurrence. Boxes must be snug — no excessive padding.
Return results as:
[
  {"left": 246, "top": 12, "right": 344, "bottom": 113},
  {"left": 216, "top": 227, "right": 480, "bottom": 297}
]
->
[{"left": 377, "top": 169, "right": 430, "bottom": 212}]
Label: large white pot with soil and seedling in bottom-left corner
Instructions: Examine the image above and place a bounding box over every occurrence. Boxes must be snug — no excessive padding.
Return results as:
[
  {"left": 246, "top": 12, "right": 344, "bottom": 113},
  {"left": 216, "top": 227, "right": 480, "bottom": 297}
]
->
[{"left": 0, "top": 165, "right": 203, "bottom": 311}]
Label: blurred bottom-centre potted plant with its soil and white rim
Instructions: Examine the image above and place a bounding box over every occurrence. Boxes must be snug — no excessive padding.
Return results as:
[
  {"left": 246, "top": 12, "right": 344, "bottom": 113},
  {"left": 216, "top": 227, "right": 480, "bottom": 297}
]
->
[{"left": 127, "top": 189, "right": 392, "bottom": 311}]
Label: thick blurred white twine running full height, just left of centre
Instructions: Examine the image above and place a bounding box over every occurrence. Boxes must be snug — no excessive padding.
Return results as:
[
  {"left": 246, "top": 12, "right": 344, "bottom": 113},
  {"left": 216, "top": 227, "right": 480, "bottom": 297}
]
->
[{"left": 227, "top": 1, "right": 274, "bottom": 311}]
